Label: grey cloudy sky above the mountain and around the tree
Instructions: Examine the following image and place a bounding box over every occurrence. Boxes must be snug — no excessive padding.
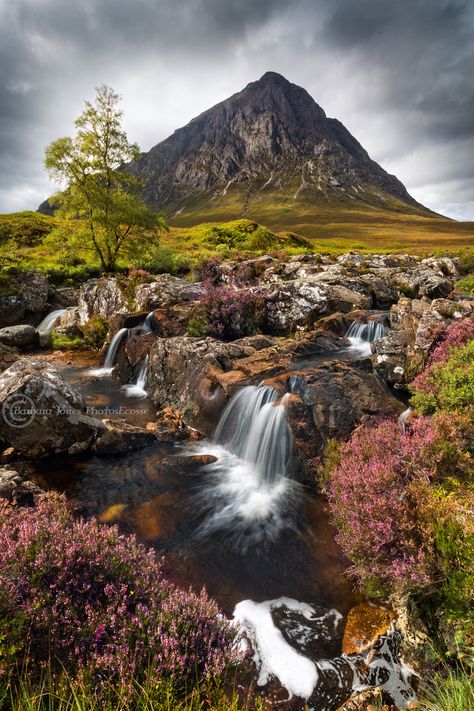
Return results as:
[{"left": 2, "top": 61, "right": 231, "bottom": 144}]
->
[{"left": 0, "top": 0, "right": 474, "bottom": 220}]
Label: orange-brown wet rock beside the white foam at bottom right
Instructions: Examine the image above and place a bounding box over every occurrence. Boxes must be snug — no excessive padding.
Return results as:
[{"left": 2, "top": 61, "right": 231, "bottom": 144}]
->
[{"left": 342, "top": 602, "right": 395, "bottom": 654}]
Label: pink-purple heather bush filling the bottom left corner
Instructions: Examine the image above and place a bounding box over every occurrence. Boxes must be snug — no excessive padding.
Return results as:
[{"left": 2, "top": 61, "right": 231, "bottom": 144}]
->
[{"left": 0, "top": 495, "right": 232, "bottom": 698}]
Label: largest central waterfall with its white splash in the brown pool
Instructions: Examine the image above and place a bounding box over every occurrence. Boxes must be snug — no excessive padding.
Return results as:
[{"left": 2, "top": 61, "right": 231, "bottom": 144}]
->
[{"left": 191, "top": 385, "right": 300, "bottom": 551}]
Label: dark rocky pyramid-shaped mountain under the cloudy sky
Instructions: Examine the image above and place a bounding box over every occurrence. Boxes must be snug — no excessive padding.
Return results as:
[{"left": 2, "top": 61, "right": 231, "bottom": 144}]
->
[{"left": 129, "top": 72, "right": 433, "bottom": 227}]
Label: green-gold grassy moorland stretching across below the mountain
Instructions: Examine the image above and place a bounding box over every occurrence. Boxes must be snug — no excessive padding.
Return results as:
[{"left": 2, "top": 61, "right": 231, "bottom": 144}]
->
[{"left": 0, "top": 204, "right": 474, "bottom": 293}]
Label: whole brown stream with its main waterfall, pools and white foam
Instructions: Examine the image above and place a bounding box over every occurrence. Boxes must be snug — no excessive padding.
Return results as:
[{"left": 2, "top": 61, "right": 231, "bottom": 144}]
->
[{"left": 27, "top": 324, "right": 414, "bottom": 711}]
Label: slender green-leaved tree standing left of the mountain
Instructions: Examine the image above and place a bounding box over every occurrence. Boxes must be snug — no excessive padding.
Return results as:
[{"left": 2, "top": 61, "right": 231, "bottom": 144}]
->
[{"left": 45, "top": 85, "right": 167, "bottom": 271}]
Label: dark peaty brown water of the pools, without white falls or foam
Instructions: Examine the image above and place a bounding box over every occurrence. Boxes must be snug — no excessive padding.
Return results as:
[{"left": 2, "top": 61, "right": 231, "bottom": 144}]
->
[{"left": 31, "top": 356, "right": 358, "bottom": 614}]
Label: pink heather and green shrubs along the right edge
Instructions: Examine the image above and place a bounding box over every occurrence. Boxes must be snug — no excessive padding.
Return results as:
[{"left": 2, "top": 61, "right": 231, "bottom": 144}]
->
[{"left": 324, "top": 319, "right": 474, "bottom": 660}]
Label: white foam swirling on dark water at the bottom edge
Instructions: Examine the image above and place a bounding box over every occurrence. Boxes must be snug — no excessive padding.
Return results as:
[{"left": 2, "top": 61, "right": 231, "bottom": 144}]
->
[{"left": 233, "top": 597, "right": 415, "bottom": 709}]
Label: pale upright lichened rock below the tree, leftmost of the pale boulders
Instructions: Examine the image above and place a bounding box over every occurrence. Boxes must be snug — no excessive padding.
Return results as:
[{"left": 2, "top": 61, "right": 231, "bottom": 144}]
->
[{"left": 78, "top": 277, "right": 130, "bottom": 324}]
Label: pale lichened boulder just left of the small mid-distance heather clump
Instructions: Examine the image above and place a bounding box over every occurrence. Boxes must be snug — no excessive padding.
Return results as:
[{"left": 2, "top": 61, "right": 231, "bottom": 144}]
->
[{"left": 135, "top": 274, "right": 203, "bottom": 311}]
